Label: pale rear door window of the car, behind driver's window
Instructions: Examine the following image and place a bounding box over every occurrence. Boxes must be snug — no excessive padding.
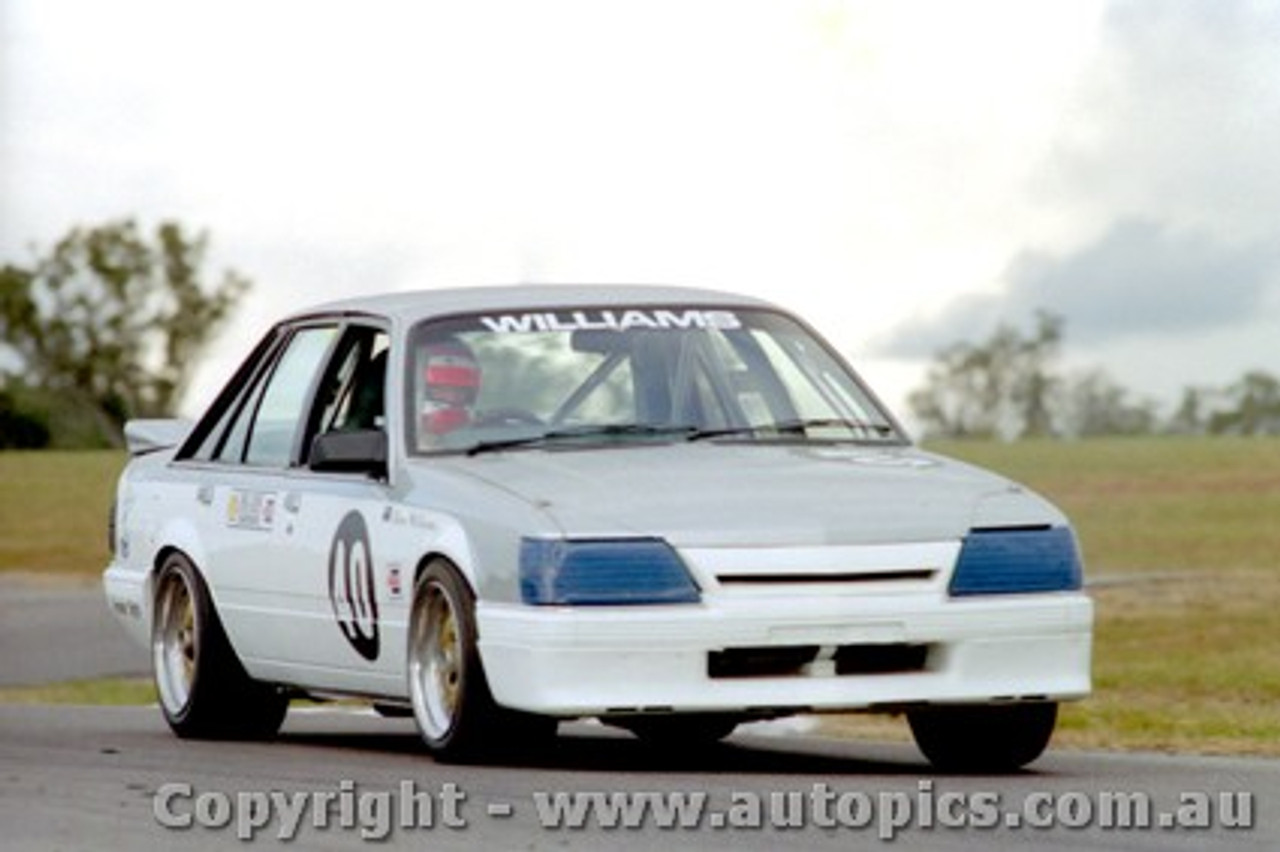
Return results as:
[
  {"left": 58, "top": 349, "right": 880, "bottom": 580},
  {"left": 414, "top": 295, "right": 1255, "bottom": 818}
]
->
[{"left": 235, "top": 326, "right": 338, "bottom": 467}]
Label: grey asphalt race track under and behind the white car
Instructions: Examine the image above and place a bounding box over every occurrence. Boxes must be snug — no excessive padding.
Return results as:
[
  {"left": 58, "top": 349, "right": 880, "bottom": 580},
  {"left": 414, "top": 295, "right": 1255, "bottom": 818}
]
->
[{"left": 0, "top": 573, "right": 1280, "bottom": 852}]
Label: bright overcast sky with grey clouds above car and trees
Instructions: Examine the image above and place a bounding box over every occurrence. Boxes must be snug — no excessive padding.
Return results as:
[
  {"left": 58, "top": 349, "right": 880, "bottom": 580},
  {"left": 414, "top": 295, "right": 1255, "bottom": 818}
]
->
[{"left": 0, "top": 0, "right": 1280, "bottom": 419}]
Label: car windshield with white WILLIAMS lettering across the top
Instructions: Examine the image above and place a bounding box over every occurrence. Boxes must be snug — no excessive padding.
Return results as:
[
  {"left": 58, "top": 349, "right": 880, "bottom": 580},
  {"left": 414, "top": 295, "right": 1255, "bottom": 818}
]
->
[{"left": 404, "top": 306, "right": 905, "bottom": 454}]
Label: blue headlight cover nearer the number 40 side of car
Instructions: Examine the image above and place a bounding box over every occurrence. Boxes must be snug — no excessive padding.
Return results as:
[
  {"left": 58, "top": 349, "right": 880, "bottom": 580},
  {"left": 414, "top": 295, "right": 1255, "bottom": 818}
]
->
[{"left": 520, "top": 539, "right": 700, "bottom": 606}]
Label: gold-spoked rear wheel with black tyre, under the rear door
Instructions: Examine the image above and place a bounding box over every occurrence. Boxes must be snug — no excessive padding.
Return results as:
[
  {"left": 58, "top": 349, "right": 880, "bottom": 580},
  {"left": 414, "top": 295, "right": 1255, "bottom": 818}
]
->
[{"left": 151, "top": 553, "right": 289, "bottom": 739}]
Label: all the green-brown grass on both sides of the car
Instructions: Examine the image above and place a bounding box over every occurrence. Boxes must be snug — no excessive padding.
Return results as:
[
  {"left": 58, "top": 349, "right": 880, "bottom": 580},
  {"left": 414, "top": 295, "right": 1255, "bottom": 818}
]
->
[{"left": 0, "top": 438, "right": 1280, "bottom": 755}]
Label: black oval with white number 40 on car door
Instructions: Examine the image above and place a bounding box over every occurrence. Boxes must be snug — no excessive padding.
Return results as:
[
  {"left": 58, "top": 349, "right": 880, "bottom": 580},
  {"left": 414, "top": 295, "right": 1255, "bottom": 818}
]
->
[{"left": 329, "top": 512, "right": 379, "bottom": 661}]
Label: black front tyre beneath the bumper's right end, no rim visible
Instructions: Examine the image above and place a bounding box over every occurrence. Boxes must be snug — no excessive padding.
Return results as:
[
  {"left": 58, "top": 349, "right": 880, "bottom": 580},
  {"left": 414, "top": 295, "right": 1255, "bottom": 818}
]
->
[{"left": 906, "top": 701, "right": 1057, "bottom": 773}]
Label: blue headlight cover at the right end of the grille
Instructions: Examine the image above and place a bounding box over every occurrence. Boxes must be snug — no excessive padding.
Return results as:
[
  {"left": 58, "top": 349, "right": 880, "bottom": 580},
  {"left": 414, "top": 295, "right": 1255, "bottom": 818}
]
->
[{"left": 948, "top": 527, "right": 1083, "bottom": 597}]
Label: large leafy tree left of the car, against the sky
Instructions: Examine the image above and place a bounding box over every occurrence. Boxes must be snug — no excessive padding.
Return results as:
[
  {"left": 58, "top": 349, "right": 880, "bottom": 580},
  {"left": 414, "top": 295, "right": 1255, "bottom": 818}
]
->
[{"left": 0, "top": 220, "right": 250, "bottom": 444}]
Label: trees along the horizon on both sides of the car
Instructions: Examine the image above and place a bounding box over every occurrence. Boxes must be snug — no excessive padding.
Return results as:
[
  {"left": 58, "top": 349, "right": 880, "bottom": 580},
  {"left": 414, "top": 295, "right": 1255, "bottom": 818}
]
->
[{"left": 0, "top": 219, "right": 1280, "bottom": 449}]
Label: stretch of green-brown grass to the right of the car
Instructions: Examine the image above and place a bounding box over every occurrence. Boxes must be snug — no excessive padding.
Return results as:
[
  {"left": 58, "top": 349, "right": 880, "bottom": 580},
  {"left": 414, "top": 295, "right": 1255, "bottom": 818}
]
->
[{"left": 931, "top": 438, "right": 1280, "bottom": 755}]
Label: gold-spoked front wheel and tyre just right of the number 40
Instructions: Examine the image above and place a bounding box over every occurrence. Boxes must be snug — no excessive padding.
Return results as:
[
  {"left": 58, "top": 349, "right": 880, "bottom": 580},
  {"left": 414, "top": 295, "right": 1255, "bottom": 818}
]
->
[{"left": 407, "top": 559, "right": 557, "bottom": 761}]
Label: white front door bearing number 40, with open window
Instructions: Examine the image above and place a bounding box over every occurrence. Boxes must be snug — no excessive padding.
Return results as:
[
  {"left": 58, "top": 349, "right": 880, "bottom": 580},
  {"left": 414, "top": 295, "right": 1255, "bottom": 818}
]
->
[{"left": 263, "top": 325, "right": 412, "bottom": 695}]
